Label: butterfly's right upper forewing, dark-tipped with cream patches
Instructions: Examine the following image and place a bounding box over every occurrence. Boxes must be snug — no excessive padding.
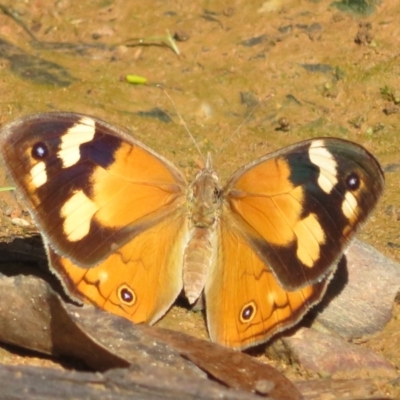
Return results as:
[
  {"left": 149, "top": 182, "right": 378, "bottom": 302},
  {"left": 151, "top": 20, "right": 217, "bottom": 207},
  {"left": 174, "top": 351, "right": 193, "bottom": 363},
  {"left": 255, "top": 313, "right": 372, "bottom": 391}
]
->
[{"left": 222, "top": 138, "right": 384, "bottom": 290}]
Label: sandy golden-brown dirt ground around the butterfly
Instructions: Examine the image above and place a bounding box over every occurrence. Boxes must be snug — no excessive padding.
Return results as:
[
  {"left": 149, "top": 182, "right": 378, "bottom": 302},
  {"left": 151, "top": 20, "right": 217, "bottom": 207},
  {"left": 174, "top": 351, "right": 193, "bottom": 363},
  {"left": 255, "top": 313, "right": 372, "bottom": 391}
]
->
[{"left": 0, "top": 0, "right": 400, "bottom": 397}]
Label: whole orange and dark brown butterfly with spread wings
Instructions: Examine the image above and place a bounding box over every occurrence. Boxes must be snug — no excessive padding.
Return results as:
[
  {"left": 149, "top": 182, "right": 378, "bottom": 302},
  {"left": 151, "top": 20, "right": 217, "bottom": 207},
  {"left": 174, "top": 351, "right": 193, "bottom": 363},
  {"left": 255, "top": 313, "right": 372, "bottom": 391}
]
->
[{"left": 0, "top": 112, "right": 384, "bottom": 350}]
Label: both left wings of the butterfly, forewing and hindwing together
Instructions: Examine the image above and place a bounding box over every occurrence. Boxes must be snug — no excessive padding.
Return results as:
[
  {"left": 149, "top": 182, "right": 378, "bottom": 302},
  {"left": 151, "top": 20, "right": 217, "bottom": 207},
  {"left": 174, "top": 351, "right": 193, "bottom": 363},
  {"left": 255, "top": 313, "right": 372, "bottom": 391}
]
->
[{"left": 0, "top": 113, "right": 188, "bottom": 322}]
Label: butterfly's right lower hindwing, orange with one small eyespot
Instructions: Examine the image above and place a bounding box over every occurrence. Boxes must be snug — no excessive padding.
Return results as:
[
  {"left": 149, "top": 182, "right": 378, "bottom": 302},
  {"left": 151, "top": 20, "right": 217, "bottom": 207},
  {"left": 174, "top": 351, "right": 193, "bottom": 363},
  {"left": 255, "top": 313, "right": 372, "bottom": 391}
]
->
[{"left": 205, "top": 217, "right": 328, "bottom": 350}]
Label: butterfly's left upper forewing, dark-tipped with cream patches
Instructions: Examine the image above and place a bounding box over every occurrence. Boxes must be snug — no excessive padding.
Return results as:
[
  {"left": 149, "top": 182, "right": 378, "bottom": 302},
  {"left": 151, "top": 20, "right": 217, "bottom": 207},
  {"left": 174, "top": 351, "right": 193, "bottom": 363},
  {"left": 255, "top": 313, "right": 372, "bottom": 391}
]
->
[{"left": 0, "top": 112, "right": 186, "bottom": 267}]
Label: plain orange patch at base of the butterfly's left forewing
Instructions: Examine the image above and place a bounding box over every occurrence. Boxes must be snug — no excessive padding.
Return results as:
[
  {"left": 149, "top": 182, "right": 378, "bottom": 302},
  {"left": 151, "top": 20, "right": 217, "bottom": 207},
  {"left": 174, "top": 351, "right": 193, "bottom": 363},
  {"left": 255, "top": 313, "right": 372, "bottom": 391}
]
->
[{"left": 91, "top": 143, "right": 185, "bottom": 231}]
